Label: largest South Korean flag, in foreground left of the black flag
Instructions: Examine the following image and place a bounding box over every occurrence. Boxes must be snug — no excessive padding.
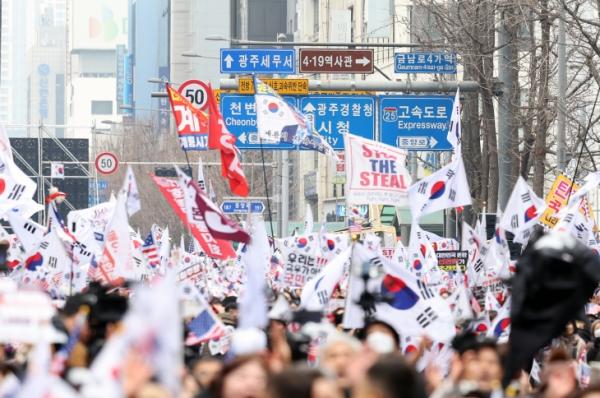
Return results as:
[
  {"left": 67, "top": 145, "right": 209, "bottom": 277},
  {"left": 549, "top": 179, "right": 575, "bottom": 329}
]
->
[{"left": 344, "top": 243, "right": 456, "bottom": 342}]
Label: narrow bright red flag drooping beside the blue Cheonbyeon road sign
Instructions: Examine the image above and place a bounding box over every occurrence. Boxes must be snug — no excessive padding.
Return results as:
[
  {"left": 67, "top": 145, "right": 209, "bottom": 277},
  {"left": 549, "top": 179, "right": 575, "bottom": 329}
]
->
[{"left": 208, "top": 84, "right": 249, "bottom": 196}]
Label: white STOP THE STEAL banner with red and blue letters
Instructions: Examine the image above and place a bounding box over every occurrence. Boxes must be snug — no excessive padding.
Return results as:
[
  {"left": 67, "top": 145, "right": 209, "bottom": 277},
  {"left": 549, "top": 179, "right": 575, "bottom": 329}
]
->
[{"left": 344, "top": 134, "right": 411, "bottom": 206}]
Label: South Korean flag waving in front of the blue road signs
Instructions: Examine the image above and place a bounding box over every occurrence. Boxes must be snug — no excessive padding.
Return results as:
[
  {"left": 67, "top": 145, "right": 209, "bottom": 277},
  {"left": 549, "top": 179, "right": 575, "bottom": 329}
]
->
[{"left": 254, "top": 78, "right": 308, "bottom": 144}]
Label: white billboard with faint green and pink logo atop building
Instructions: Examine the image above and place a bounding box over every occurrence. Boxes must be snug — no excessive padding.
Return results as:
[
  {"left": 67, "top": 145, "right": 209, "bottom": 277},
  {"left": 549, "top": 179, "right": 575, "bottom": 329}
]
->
[{"left": 71, "top": 0, "right": 128, "bottom": 50}]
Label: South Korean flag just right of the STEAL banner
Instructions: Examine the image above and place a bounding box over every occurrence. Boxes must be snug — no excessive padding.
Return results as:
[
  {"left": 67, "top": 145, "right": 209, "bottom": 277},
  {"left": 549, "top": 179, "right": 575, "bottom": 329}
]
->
[{"left": 408, "top": 154, "right": 471, "bottom": 220}]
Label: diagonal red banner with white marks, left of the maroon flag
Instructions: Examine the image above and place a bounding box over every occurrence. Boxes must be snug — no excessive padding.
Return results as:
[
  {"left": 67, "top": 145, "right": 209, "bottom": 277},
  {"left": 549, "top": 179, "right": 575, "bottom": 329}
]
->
[{"left": 152, "top": 176, "right": 235, "bottom": 260}]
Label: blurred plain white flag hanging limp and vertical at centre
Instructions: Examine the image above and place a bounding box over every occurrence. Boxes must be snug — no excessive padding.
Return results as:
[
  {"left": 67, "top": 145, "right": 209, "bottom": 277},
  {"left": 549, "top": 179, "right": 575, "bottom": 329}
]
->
[{"left": 239, "top": 216, "right": 271, "bottom": 329}]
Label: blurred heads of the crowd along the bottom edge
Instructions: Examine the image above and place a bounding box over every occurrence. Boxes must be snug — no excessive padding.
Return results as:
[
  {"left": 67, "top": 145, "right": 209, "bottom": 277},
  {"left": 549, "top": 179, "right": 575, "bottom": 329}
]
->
[{"left": 0, "top": 246, "right": 600, "bottom": 398}]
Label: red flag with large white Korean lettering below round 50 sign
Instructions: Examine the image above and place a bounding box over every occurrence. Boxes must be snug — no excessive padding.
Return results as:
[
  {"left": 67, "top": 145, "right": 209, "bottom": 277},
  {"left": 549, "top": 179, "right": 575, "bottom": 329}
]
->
[{"left": 166, "top": 84, "right": 208, "bottom": 151}]
